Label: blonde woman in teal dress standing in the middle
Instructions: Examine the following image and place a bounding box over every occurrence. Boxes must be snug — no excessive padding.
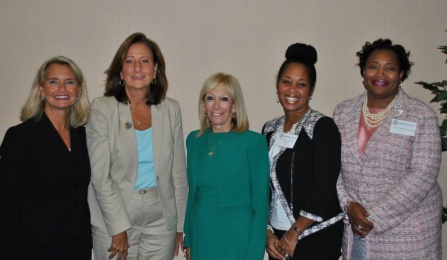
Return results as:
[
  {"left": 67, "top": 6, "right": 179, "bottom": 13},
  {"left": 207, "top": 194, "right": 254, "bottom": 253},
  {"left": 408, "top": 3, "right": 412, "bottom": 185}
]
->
[{"left": 184, "top": 73, "right": 269, "bottom": 260}]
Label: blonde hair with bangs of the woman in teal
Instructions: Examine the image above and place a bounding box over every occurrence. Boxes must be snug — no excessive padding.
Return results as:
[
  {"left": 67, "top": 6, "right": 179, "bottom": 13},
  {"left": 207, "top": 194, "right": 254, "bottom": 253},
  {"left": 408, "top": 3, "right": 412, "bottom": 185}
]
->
[{"left": 197, "top": 72, "right": 249, "bottom": 137}]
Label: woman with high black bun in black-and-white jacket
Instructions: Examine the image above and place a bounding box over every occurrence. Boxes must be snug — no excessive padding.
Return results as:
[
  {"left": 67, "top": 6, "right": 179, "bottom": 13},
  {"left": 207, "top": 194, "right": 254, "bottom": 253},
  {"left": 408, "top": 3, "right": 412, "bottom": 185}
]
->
[{"left": 262, "top": 43, "right": 343, "bottom": 259}]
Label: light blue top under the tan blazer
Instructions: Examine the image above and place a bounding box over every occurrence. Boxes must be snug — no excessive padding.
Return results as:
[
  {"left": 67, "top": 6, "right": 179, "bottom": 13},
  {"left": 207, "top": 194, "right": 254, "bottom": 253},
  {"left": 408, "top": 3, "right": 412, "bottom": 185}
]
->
[{"left": 134, "top": 128, "right": 157, "bottom": 190}]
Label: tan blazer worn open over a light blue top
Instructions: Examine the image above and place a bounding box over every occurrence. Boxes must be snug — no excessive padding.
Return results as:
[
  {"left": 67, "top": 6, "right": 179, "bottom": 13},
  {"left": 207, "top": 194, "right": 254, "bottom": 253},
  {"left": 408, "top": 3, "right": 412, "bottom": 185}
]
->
[{"left": 86, "top": 97, "right": 188, "bottom": 236}]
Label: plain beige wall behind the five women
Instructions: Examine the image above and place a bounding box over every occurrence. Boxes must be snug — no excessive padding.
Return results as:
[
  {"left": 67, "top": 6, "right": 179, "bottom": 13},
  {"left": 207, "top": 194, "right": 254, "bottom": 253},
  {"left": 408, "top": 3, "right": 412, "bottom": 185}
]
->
[{"left": 0, "top": 0, "right": 447, "bottom": 256}]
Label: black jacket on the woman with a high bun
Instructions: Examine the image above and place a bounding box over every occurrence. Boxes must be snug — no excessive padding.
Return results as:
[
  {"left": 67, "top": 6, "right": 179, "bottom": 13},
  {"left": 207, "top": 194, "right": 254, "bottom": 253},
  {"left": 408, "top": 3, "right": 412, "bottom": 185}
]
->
[{"left": 263, "top": 117, "right": 342, "bottom": 225}]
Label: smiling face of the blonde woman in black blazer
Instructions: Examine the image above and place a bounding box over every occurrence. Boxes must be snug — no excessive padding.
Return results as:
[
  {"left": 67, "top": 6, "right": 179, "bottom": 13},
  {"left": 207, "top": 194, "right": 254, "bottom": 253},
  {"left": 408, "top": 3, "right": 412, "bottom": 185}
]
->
[{"left": 37, "top": 63, "right": 81, "bottom": 114}]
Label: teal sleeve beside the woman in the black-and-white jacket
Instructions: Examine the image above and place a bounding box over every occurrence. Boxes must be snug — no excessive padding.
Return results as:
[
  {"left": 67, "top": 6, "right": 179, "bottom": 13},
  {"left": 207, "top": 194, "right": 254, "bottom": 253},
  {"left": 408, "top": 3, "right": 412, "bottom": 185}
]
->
[{"left": 245, "top": 135, "right": 270, "bottom": 260}]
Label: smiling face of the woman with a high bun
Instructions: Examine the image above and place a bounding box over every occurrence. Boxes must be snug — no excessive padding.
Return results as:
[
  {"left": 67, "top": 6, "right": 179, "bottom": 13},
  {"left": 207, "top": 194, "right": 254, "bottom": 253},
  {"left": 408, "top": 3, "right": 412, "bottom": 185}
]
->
[{"left": 277, "top": 62, "right": 312, "bottom": 115}]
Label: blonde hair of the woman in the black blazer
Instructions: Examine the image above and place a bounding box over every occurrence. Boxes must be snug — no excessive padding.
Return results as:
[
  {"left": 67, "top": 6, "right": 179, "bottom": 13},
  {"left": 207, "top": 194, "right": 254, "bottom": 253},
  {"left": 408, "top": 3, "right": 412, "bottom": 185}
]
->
[{"left": 20, "top": 56, "right": 90, "bottom": 127}]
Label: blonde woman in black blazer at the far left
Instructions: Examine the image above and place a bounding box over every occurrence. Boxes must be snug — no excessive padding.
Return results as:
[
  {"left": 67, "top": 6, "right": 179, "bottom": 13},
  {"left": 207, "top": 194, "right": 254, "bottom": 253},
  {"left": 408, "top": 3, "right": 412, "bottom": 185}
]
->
[{"left": 0, "top": 56, "right": 92, "bottom": 260}]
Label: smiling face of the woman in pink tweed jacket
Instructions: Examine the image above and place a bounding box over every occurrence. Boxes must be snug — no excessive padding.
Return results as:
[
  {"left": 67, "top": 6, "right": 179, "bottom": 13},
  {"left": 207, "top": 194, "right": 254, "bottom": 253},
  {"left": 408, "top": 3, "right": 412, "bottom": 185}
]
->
[{"left": 363, "top": 49, "right": 403, "bottom": 105}]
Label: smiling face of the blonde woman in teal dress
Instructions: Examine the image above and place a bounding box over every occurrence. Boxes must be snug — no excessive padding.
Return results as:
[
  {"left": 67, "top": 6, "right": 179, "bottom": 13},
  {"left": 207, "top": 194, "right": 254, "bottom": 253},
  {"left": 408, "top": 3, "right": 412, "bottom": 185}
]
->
[{"left": 204, "top": 83, "right": 236, "bottom": 132}]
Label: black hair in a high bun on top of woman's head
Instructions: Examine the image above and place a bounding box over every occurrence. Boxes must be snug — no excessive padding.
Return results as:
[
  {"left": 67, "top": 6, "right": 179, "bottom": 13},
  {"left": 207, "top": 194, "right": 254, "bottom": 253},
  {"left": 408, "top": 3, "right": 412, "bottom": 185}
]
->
[{"left": 276, "top": 43, "right": 317, "bottom": 92}]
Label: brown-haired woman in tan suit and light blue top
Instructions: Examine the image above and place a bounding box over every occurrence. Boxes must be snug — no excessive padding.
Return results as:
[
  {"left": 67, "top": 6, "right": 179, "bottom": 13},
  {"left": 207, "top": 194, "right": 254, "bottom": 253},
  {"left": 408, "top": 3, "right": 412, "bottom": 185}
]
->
[{"left": 87, "top": 33, "right": 188, "bottom": 260}]
